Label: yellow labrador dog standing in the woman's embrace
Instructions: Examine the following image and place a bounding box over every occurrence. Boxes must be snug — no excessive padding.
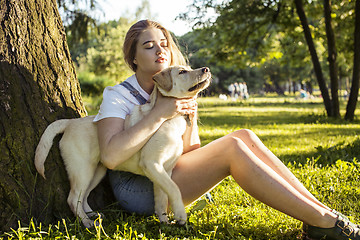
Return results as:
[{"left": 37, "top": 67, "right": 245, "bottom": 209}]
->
[{"left": 35, "top": 66, "right": 211, "bottom": 227}]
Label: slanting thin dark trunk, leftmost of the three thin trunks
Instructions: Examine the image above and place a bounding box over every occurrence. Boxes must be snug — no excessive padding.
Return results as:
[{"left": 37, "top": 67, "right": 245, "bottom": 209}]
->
[{"left": 294, "top": 0, "right": 333, "bottom": 116}]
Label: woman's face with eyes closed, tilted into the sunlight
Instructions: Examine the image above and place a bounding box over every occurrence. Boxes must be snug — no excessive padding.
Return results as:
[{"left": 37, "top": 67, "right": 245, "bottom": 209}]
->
[{"left": 134, "top": 28, "right": 171, "bottom": 75}]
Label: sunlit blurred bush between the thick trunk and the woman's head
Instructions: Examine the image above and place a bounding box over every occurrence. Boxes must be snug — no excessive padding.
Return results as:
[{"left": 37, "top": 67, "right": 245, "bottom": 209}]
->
[{"left": 73, "top": 18, "right": 136, "bottom": 107}]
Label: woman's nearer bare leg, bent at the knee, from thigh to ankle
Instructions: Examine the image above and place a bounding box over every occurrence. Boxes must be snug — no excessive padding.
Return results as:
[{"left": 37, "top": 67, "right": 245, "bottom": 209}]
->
[{"left": 172, "top": 135, "right": 337, "bottom": 228}]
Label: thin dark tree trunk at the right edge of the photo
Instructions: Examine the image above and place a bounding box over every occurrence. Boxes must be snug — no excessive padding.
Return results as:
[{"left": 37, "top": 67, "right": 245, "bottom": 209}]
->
[{"left": 345, "top": 0, "right": 360, "bottom": 121}]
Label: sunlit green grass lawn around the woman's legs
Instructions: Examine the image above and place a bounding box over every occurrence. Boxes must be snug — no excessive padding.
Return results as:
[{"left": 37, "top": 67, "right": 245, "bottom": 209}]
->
[{"left": 0, "top": 97, "right": 360, "bottom": 239}]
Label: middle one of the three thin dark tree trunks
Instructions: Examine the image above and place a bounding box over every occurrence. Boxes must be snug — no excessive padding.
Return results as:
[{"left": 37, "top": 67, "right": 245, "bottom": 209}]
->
[{"left": 324, "top": 0, "right": 340, "bottom": 118}]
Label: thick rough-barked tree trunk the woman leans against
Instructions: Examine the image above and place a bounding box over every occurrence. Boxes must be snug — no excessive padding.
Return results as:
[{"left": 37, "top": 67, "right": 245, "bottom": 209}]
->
[{"left": 0, "top": 0, "right": 85, "bottom": 231}]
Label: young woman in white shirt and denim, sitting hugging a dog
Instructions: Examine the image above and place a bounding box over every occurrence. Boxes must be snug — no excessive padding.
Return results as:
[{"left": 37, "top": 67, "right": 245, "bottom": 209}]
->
[{"left": 95, "top": 20, "right": 360, "bottom": 240}]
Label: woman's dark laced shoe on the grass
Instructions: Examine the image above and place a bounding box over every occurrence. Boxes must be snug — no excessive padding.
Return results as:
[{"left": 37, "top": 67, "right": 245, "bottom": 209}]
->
[{"left": 303, "top": 216, "right": 360, "bottom": 240}]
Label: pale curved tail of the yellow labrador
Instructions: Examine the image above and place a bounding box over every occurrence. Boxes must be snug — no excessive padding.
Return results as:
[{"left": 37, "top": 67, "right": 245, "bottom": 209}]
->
[{"left": 34, "top": 119, "right": 71, "bottom": 178}]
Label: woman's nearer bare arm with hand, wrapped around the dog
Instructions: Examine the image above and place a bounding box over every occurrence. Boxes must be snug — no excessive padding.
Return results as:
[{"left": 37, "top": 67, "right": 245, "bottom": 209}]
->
[{"left": 97, "top": 94, "right": 194, "bottom": 169}]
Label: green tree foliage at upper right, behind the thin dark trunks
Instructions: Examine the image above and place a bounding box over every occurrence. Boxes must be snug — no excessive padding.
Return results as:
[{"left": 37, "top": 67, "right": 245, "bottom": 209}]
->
[{"left": 180, "top": 0, "right": 355, "bottom": 101}]
